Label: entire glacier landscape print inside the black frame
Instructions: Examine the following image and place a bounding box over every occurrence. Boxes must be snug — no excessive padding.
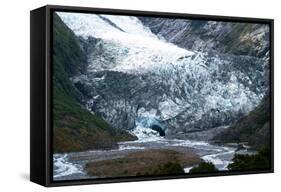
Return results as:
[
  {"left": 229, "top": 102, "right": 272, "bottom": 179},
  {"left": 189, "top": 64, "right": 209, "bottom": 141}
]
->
[{"left": 52, "top": 11, "right": 271, "bottom": 181}]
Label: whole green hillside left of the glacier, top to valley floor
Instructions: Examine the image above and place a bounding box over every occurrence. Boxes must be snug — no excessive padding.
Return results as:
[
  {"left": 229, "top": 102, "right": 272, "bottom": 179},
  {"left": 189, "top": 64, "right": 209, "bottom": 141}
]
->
[{"left": 53, "top": 14, "right": 136, "bottom": 153}]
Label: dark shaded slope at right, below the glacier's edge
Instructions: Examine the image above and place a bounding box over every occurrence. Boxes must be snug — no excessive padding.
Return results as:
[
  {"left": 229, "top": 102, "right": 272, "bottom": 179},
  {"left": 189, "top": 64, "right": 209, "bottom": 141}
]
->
[{"left": 213, "top": 96, "right": 270, "bottom": 150}]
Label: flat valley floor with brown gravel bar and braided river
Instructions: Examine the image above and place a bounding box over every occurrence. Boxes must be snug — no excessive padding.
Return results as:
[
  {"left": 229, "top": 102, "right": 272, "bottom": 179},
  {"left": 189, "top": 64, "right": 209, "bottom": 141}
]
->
[{"left": 53, "top": 137, "right": 254, "bottom": 180}]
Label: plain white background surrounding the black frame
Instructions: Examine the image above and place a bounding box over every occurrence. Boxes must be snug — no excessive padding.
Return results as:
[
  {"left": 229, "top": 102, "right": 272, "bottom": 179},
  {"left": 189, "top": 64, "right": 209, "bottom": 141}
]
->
[{"left": 0, "top": 0, "right": 276, "bottom": 192}]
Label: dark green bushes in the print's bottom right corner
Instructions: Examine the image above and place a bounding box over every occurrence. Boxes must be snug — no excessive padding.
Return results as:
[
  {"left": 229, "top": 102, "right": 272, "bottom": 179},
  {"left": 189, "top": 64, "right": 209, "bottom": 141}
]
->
[{"left": 228, "top": 148, "right": 271, "bottom": 171}]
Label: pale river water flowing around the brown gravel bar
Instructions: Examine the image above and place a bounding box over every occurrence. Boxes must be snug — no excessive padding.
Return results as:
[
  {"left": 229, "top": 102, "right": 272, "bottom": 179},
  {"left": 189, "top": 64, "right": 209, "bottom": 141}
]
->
[{"left": 53, "top": 137, "right": 254, "bottom": 180}]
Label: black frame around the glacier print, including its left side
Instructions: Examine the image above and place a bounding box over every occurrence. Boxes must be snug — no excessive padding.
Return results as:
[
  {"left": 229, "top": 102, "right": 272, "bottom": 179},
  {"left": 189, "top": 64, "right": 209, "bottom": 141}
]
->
[{"left": 30, "top": 5, "right": 274, "bottom": 186}]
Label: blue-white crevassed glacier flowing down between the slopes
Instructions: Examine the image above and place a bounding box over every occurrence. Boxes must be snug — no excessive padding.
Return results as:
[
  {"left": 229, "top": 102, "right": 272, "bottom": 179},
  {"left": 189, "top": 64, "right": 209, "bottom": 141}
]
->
[{"left": 57, "top": 12, "right": 269, "bottom": 137}]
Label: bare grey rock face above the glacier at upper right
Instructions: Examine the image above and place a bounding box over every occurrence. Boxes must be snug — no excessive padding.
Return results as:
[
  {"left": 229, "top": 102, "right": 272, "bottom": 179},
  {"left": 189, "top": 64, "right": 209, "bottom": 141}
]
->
[{"left": 139, "top": 17, "right": 269, "bottom": 57}]
